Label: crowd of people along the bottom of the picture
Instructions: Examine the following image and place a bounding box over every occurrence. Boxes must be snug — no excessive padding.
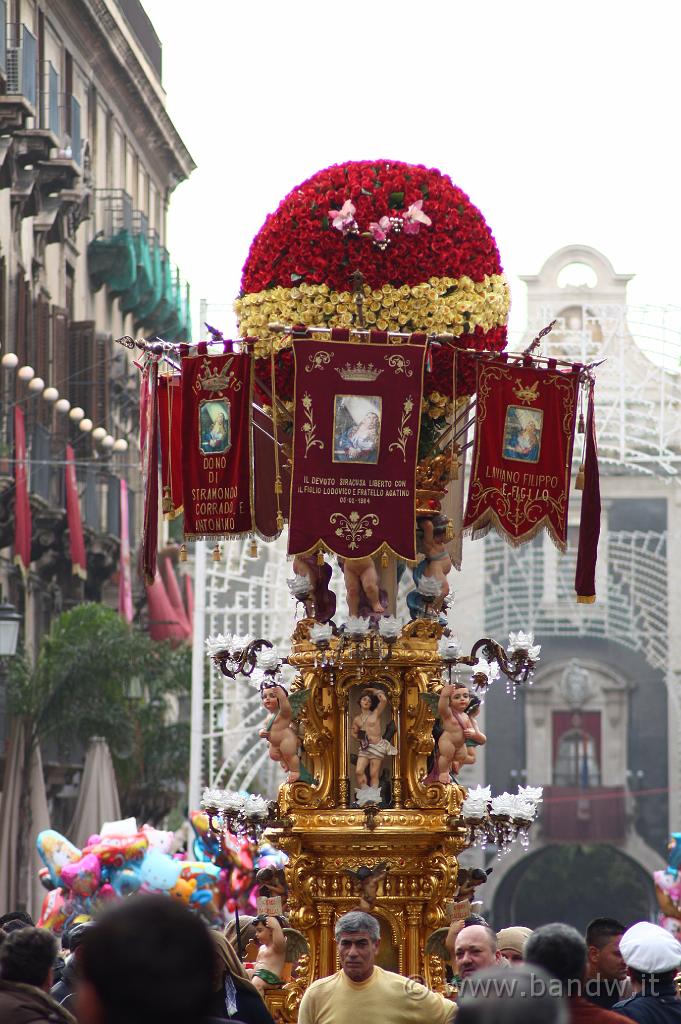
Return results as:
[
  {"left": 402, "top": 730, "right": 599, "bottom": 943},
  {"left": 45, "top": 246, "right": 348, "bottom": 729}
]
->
[{"left": 0, "top": 896, "right": 681, "bottom": 1024}]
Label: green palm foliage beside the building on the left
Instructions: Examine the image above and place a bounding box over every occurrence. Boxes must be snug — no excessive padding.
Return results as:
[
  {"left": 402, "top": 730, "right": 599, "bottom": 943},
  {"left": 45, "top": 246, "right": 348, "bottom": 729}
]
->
[{"left": 8, "top": 604, "right": 191, "bottom": 822}]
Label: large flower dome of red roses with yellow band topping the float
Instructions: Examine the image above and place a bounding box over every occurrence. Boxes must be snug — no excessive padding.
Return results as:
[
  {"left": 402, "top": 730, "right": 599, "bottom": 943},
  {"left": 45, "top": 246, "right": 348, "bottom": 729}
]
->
[{"left": 235, "top": 160, "right": 509, "bottom": 397}]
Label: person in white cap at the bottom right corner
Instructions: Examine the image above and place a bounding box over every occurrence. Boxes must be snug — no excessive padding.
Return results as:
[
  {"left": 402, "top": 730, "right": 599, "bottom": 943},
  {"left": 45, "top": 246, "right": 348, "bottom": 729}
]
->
[{"left": 612, "top": 921, "right": 681, "bottom": 1024}]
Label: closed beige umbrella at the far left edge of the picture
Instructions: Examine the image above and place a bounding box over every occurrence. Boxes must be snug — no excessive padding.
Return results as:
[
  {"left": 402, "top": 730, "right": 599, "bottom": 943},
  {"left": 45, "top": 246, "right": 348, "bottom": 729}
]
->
[{"left": 0, "top": 718, "right": 50, "bottom": 920}]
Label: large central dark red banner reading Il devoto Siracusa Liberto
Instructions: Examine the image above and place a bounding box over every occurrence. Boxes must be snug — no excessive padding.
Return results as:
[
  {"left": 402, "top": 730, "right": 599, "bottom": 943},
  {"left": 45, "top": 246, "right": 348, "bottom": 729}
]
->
[{"left": 289, "top": 338, "right": 426, "bottom": 561}]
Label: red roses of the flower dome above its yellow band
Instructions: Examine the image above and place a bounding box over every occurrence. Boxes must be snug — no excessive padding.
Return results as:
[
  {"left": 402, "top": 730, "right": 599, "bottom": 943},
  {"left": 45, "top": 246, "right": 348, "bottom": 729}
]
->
[{"left": 242, "top": 160, "right": 502, "bottom": 295}]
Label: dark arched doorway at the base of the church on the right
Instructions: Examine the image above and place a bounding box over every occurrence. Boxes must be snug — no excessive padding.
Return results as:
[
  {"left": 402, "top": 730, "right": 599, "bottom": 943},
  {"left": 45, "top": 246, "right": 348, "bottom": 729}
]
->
[{"left": 493, "top": 843, "right": 656, "bottom": 933}]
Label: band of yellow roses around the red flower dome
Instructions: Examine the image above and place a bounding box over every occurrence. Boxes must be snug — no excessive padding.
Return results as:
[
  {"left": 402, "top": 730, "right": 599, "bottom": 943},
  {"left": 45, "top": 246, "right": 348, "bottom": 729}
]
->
[{"left": 235, "top": 274, "right": 510, "bottom": 356}]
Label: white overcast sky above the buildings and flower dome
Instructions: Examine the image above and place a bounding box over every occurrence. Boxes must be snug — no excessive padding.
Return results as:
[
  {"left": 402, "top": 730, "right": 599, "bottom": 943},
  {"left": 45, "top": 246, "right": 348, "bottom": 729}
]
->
[{"left": 142, "top": 0, "right": 681, "bottom": 346}]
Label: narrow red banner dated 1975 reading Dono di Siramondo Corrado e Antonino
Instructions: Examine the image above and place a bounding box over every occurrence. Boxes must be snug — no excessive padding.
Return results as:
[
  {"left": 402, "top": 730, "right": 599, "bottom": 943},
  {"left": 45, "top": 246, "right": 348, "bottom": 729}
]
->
[{"left": 182, "top": 352, "right": 253, "bottom": 540}]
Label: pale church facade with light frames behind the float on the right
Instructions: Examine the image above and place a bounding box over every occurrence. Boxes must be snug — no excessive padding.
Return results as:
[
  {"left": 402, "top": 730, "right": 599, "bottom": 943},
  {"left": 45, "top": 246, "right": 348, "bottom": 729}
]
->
[{"left": 473, "top": 246, "right": 681, "bottom": 927}]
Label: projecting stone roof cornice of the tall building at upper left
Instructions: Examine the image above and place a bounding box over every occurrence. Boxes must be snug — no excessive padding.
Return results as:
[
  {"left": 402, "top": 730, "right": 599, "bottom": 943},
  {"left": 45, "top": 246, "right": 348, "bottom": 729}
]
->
[{"left": 50, "top": 0, "right": 196, "bottom": 189}]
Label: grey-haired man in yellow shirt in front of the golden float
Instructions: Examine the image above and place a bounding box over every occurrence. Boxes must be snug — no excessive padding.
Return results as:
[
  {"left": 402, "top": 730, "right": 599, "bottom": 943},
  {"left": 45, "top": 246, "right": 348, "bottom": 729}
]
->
[{"left": 298, "top": 910, "right": 457, "bottom": 1024}]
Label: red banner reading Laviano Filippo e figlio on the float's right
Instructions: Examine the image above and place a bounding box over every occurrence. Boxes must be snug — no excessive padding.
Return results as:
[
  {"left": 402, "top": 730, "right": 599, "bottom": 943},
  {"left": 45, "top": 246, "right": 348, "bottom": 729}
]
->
[{"left": 463, "top": 358, "right": 581, "bottom": 551}]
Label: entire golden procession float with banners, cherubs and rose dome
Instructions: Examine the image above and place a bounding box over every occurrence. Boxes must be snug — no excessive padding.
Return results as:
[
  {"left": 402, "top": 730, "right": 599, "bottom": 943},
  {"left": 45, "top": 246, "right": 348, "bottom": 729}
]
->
[{"left": 37, "top": 160, "right": 600, "bottom": 1021}]
